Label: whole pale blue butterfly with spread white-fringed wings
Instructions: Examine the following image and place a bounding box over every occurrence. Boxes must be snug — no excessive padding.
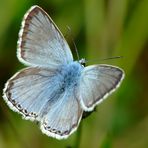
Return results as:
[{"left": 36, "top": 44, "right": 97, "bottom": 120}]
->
[{"left": 3, "top": 6, "right": 124, "bottom": 139}]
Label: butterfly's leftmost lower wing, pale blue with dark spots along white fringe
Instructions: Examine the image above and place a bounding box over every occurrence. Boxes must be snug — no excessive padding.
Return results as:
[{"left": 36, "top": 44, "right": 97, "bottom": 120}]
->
[{"left": 4, "top": 68, "right": 57, "bottom": 120}]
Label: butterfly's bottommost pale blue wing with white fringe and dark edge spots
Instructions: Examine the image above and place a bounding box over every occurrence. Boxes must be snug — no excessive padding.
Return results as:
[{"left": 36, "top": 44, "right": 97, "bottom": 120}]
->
[{"left": 41, "top": 91, "right": 83, "bottom": 139}]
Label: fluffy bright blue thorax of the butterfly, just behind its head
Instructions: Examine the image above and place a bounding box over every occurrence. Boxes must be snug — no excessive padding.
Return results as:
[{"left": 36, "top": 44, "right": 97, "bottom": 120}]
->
[{"left": 59, "top": 62, "right": 83, "bottom": 90}]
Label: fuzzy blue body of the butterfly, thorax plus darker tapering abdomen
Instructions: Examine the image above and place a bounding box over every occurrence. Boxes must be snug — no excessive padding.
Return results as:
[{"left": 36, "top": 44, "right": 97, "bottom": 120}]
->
[{"left": 39, "top": 61, "right": 84, "bottom": 115}]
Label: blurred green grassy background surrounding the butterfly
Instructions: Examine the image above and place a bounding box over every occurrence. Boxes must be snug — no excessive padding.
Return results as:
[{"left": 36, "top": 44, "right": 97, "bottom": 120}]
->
[{"left": 0, "top": 0, "right": 148, "bottom": 148}]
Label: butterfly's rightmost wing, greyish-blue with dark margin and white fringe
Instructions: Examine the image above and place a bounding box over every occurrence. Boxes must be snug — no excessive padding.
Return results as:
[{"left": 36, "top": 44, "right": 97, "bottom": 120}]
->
[{"left": 79, "top": 64, "right": 124, "bottom": 111}]
